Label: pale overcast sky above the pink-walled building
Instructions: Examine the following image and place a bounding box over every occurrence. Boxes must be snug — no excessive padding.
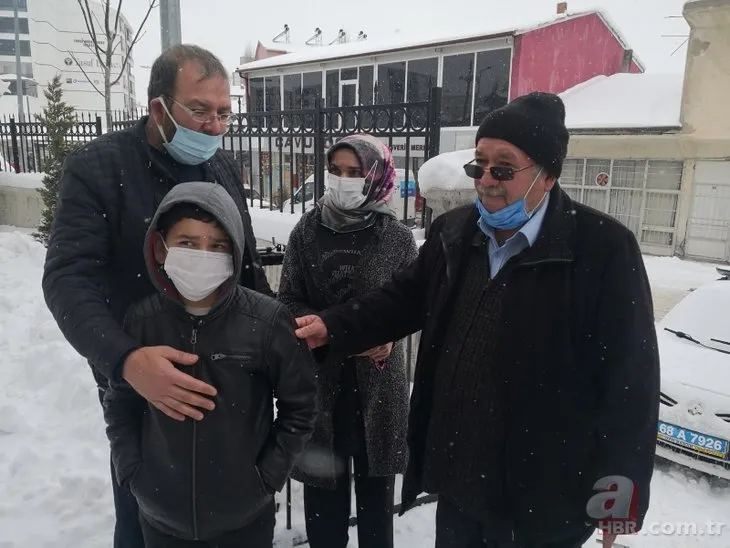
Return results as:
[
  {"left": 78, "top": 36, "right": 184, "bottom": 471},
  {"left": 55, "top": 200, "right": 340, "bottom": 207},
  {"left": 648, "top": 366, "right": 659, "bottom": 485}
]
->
[{"left": 122, "top": 0, "right": 689, "bottom": 103}]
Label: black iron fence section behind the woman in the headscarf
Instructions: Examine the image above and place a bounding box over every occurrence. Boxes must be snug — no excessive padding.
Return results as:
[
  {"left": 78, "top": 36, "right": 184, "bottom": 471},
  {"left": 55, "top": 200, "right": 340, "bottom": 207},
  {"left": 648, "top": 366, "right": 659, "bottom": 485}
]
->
[{"left": 223, "top": 88, "right": 441, "bottom": 227}]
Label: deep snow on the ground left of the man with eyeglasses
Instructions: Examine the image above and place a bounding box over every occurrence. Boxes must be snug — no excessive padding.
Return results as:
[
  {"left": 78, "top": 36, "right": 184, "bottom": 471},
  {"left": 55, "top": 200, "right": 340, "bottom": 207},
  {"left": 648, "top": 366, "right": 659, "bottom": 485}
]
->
[{"left": 0, "top": 232, "right": 114, "bottom": 548}]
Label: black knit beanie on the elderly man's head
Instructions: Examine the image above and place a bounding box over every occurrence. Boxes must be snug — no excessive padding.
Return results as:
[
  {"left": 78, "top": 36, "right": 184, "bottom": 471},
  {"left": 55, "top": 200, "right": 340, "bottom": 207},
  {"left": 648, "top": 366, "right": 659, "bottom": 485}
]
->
[{"left": 476, "top": 91, "right": 570, "bottom": 179}]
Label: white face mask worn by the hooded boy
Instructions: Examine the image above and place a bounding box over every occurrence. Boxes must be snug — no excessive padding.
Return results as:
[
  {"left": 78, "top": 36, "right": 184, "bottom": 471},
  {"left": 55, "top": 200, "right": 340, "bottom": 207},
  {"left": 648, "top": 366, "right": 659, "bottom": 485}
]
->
[{"left": 164, "top": 246, "right": 233, "bottom": 303}]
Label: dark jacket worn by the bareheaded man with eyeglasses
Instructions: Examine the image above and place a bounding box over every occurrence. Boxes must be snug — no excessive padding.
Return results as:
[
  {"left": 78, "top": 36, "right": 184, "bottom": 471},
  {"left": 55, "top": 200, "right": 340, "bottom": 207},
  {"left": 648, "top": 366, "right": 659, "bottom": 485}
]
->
[{"left": 38, "top": 117, "right": 273, "bottom": 388}]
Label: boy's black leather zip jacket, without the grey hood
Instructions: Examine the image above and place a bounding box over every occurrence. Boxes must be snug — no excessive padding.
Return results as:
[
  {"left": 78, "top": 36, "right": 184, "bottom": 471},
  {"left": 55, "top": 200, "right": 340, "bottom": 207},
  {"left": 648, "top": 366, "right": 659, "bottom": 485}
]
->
[{"left": 104, "top": 286, "right": 316, "bottom": 540}]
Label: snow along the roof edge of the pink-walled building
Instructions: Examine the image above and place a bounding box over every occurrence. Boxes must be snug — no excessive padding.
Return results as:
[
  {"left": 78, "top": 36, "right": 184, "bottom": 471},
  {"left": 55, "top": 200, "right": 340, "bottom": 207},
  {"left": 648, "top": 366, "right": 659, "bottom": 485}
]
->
[{"left": 238, "top": 10, "right": 624, "bottom": 72}]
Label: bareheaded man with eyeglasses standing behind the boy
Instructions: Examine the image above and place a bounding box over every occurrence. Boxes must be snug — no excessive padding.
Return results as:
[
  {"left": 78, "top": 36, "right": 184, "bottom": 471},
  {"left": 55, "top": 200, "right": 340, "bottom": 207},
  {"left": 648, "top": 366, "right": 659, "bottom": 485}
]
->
[{"left": 43, "top": 45, "right": 273, "bottom": 548}]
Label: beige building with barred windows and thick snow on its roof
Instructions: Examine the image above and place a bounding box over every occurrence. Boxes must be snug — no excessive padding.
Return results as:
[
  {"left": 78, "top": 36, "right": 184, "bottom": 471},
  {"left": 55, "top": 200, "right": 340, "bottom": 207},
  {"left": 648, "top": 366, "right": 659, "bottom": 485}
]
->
[{"left": 418, "top": 0, "right": 730, "bottom": 264}]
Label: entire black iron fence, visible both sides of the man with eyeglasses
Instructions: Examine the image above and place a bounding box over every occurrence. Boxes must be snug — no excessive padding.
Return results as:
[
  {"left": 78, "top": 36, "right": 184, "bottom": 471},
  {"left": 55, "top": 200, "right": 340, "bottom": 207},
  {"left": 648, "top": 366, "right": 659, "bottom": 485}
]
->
[{"left": 0, "top": 88, "right": 441, "bottom": 228}]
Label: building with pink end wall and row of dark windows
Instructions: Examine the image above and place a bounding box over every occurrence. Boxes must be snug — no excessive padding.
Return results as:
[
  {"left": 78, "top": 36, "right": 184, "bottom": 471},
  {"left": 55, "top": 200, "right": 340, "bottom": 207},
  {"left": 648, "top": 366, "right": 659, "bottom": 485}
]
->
[{"left": 238, "top": 7, "right": 643, "bottom": 203}]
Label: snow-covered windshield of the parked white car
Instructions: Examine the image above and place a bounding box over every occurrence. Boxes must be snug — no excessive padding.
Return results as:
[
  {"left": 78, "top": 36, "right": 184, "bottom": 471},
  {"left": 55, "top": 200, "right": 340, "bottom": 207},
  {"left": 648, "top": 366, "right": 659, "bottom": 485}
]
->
[{"left": 660, "top": 280, "right": 730, "bottom": 353}]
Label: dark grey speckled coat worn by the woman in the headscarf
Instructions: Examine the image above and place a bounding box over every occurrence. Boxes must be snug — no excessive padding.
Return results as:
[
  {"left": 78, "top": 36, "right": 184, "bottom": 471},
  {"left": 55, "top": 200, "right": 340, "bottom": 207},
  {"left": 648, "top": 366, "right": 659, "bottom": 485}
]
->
[{"left": 279, "top": 208, "right": 418, "bottom": 488}]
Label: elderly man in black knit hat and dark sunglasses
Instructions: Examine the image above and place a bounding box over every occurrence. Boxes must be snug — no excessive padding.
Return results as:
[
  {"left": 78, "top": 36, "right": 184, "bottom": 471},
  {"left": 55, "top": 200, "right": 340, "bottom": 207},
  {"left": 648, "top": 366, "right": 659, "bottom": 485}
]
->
[{"left": 297, "top": 92, "right": 659, "bottom": 548}]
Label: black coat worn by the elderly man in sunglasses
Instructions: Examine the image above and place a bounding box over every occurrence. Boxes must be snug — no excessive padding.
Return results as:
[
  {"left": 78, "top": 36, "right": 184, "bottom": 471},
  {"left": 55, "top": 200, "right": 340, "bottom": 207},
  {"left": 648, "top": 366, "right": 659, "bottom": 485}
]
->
[{"left": 321, "top": 184, "right": 659, "bottom": 542}]
